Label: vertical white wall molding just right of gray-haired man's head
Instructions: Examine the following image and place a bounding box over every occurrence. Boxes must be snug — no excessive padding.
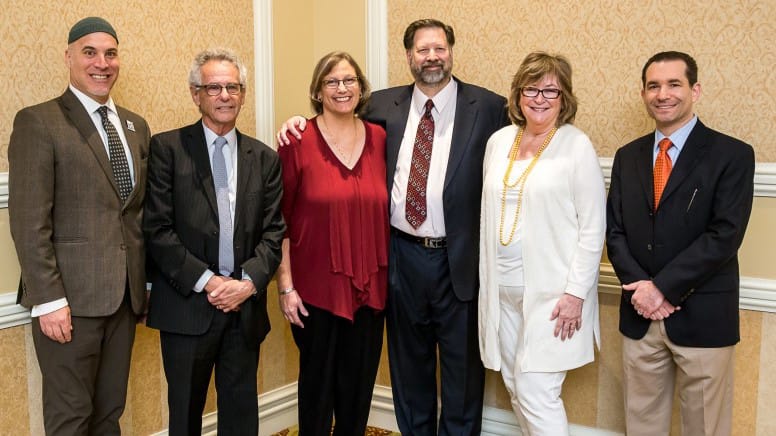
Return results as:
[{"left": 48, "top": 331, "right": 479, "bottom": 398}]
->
[{"left": 252, "top": 0, "right": 275, "bottom": 146}]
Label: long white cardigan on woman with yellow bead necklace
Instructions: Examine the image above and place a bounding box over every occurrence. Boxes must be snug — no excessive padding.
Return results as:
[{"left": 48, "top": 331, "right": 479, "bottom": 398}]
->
[{"left": 479, "top": 124, "right": 606, "bottom": 372}]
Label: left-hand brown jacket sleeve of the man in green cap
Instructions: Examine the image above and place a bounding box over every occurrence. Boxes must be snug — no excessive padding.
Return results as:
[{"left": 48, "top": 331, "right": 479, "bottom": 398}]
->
[{"left": 8, "top": 109, "right": 66, "bottom": 305}]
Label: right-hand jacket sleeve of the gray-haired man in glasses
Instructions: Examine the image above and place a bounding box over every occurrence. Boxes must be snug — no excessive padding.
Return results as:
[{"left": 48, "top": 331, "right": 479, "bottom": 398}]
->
[{"left": 241, "top": 152, "right": 286, "bottom": 290}]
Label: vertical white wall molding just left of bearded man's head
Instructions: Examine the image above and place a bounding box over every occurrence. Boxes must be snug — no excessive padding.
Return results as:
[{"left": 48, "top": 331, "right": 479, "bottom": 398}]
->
[{"left": 366, "top": 0, "right": 388, "bottom": 90}]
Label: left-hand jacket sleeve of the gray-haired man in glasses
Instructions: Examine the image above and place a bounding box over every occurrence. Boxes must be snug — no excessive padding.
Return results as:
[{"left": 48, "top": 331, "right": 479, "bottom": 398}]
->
[{"left": 143, "top": 135, "right": 208, "bottom": 295}]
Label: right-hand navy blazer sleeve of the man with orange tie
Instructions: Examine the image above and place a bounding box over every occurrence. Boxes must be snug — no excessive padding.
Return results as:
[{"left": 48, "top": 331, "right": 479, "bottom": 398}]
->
[{"left": 653, "top": 142, "right": 754, "bottom": 305}]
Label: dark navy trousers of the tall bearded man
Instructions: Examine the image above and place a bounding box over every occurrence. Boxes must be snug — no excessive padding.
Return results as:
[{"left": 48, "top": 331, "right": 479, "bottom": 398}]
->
[{"left": 386, "top": 236, "right": 485, "bottom": 436}]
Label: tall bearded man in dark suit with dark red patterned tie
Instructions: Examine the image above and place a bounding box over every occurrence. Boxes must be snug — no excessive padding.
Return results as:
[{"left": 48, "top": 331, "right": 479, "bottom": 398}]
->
[{"left": 278, "top": 19, "right": 508, "bottom": 435}]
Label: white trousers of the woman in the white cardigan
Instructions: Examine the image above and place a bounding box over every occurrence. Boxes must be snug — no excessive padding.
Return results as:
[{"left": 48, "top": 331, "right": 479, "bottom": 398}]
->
[{"left": 498, "top": 286, "right": 569, "bottom": 436}]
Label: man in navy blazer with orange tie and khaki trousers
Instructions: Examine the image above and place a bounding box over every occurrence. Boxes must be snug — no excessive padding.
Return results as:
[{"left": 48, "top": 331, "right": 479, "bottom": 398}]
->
[{"left": 607, "top": 52, "right": 754, "bottom": 435}]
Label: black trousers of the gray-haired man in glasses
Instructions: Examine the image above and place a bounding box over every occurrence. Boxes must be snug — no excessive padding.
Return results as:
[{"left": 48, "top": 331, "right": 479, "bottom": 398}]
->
[{"left": 159, "top": 311, "right": 259, "bottom": 436}]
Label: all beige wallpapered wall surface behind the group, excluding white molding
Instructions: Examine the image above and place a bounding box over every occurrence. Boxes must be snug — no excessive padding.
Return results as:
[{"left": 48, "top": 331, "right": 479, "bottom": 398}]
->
[{"left": 0, "top": 0, "right": 776, "bottom": 435}]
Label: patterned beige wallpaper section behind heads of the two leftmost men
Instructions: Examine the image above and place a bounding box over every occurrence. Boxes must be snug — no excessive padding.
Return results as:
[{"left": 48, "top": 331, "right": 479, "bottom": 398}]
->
[{"left": 0, "top": 0, "right": 256, "bottom": 171}]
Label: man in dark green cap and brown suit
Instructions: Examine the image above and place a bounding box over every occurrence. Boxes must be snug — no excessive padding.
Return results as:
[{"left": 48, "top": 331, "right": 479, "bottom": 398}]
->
[{"left": 8, "top": 17, "right": 150, "bottom": 435}]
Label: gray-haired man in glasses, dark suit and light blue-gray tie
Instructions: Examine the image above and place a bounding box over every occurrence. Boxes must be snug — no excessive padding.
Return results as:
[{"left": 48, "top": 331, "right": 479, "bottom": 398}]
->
[{"left": 143, "top": 49, "right": 286, "bottom": 435}]
